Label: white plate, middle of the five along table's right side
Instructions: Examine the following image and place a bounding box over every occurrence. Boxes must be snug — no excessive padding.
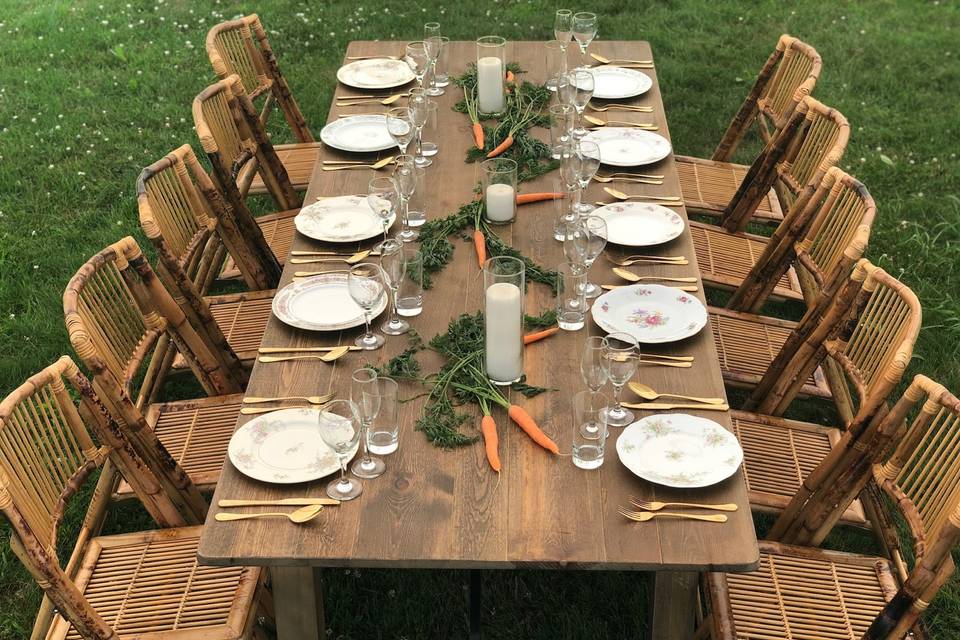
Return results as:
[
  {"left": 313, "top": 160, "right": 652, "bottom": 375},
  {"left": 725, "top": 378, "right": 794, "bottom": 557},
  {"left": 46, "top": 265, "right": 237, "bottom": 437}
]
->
[{"left": 590, "top": 202, "right": 686, "bottom": 247}]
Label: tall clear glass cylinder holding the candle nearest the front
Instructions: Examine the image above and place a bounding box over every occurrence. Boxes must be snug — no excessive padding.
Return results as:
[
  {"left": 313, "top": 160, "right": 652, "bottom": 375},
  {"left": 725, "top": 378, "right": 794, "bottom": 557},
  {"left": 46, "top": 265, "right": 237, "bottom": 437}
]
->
[{"left": 483, "top": 256, "right": 525, "bottom": 385}]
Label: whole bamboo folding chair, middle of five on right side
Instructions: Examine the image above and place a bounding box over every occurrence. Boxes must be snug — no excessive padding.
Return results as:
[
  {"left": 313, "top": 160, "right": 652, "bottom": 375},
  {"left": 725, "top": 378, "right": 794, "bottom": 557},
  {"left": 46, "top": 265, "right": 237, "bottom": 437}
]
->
[{"left": 708, "top": 167, "right": 876, "bottom": 400}]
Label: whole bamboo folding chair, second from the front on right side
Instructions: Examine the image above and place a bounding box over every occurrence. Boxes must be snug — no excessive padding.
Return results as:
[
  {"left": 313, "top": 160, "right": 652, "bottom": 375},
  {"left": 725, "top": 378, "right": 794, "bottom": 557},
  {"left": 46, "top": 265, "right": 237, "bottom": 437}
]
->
[{"left": 730, "top": 259, "right": 921, "bottom": 525}]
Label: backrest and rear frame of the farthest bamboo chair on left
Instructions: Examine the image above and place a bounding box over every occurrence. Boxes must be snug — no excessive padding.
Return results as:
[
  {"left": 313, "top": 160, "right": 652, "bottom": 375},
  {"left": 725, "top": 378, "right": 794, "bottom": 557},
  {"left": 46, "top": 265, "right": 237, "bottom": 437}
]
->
[{"left": 206, "top": 14, "right": 314, "bottom": 142}]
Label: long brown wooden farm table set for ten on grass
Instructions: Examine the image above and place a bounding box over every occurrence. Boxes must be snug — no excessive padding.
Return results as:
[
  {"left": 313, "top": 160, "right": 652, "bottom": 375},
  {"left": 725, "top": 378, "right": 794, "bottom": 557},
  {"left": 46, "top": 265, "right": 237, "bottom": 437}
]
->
[{"left": 199, "top": 41, "right": 758, "bottom": 640}]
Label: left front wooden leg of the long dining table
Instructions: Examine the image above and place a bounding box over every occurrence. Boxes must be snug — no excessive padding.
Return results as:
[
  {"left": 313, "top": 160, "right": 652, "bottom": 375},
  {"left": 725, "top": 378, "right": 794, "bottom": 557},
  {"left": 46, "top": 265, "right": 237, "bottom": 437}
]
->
[{"left": 270, "top": 567, "right": 327, "bottom": 640}]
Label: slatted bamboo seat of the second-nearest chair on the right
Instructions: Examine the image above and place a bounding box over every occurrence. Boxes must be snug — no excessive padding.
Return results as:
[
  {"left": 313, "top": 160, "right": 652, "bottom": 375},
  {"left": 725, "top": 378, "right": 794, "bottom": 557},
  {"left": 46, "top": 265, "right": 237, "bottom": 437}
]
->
[{"left": 730, "top": 411, "right": 867, "bottom": 526}]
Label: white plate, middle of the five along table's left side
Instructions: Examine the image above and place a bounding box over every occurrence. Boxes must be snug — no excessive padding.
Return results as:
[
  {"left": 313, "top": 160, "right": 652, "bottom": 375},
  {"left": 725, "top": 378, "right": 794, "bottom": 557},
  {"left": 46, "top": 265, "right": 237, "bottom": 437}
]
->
[{"left": 293, "top": 196, "right": 397, "bottom": 242}]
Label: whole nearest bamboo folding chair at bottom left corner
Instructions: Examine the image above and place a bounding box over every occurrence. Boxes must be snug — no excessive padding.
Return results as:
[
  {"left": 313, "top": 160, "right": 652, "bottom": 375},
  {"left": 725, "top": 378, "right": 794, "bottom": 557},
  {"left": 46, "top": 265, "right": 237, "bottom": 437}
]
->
[{"left": 0, "top": 356, "right": 264, "bottom": 640}]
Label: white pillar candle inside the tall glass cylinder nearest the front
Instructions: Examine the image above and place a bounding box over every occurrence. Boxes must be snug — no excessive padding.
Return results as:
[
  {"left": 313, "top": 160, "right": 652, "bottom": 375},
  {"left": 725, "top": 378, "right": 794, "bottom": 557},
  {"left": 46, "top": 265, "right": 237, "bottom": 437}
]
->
[{"left": 484, "top": 282, "right": 523, "bottom": 383}]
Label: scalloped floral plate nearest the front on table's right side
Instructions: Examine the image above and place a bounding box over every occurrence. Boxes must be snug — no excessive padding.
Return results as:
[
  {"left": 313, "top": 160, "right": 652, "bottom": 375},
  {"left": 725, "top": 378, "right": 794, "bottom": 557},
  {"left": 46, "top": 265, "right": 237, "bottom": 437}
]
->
[{"left": 617, "top": 413, "right": 743, "bottom": 489}]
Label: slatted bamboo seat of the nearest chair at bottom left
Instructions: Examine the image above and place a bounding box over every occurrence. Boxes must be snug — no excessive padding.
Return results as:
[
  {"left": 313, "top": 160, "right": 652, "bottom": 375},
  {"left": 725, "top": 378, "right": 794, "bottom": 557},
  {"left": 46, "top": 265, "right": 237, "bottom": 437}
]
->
[{"left": 46, "top": 527, "right": 263, "bottom": 640}]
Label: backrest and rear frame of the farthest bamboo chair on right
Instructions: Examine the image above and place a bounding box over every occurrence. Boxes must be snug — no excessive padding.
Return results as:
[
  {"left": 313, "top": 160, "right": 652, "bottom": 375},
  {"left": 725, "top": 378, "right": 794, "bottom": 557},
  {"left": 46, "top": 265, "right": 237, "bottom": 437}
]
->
[{"left": 713, "top": 34, "right": 823, "bottom": 162}]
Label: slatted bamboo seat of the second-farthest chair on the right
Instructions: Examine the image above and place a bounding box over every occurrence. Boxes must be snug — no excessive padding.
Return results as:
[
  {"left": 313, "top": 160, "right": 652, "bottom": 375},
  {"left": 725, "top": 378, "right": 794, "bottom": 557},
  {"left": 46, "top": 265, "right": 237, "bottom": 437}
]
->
[{"left": 690, "top": 220, "right": 803, "bottom": 300}]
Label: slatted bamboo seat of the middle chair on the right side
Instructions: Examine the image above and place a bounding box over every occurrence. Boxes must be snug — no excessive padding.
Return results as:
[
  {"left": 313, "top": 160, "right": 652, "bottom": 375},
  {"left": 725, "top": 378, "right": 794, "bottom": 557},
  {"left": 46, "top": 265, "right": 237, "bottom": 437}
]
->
[{"left": 707, "top": 307, "right": 832, "bottom": 399}]
